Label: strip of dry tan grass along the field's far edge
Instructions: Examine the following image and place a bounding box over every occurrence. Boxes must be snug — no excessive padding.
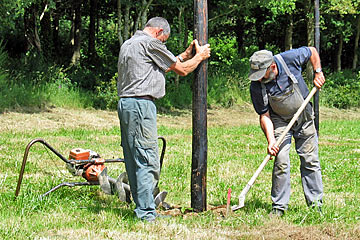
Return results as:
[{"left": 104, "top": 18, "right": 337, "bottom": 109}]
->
[{"left": 0, "top": 104, "right": 360, "bottom": 132}]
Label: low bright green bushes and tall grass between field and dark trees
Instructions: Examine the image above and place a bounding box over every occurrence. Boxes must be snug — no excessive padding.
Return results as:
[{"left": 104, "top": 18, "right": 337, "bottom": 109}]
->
[{"left": 0, "top": 39, "right": 360, "bottom": 112}]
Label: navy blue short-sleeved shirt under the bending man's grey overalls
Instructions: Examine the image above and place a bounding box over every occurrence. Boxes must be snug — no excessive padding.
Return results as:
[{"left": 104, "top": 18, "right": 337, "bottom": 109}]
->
[{"left": 250, "top": 47, "right": 311, "bottom": 115}]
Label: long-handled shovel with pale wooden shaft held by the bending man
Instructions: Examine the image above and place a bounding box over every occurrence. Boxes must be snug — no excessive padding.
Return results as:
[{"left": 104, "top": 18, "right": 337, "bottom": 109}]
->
[{"left": 231, "top": 87, "right": 317, "bottom": 211}]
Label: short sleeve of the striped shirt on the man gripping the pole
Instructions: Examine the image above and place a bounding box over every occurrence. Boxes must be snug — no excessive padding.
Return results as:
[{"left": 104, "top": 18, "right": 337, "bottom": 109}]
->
[{"left": 147, "top": 39, "right": 177, "bottom": 71}]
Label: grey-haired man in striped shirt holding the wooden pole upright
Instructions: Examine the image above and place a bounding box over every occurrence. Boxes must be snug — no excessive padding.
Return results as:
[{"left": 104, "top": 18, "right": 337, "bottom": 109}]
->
[{"left": 117, "top": 17, "right": 210, "bottom": 221}]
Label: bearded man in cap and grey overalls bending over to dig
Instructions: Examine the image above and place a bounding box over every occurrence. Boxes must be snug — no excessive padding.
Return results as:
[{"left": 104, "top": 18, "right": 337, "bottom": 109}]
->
[{"left": 249, "top": 47, "right": 325, "bottom": 216}]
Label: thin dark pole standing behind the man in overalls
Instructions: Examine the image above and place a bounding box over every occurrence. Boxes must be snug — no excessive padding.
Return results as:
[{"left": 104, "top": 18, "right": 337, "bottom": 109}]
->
[{"left": 314, "top": 0, "right": 320, "bottom": 135}]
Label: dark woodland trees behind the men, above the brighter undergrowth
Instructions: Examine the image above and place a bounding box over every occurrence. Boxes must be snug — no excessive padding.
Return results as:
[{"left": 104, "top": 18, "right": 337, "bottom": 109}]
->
[{"left": 0, "top": 0, "right": 360, "bottom": 110}]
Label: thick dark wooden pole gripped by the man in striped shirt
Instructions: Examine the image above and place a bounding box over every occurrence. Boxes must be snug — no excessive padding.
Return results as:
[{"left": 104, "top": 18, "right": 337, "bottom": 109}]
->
[{"left": 191, "top": 0, "right": 208, "bottom": 212}]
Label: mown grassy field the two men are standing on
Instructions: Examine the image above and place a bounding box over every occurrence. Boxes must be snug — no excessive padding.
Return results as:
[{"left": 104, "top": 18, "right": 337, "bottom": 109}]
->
[{"left": 0, "top": 106, "right": 360, "bottom": 239}]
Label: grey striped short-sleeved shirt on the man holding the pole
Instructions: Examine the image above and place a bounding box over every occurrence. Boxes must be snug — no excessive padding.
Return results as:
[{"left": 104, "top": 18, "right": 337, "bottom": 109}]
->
[{"left": 117, "top": 31, "right": 177, "bottom": 98}]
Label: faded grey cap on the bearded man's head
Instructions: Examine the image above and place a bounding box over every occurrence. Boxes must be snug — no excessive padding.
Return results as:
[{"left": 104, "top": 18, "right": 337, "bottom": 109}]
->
[{"left": 249, "top": 50, "right": 274, "bottom": 81}]
